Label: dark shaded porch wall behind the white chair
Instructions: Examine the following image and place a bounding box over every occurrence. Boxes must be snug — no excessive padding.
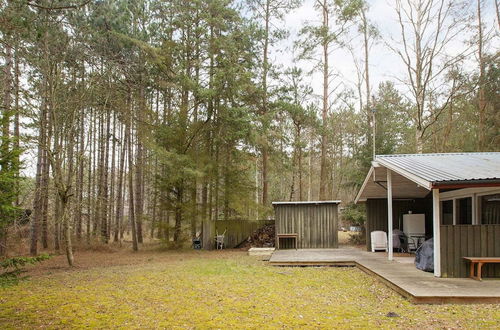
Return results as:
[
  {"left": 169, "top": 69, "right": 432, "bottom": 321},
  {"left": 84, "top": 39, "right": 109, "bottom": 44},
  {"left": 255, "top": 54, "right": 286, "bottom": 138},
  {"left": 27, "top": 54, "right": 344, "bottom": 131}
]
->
[{"left": 365, "top": 198, "right": 432, "bottom": 251}]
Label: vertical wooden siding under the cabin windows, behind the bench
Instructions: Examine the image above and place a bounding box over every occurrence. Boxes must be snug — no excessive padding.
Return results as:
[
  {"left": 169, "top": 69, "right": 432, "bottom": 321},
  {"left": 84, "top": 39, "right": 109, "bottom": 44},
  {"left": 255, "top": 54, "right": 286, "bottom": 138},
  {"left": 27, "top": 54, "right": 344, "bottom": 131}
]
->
[{"left": 441, "top": 225, "right": 500, "bottom": 277}]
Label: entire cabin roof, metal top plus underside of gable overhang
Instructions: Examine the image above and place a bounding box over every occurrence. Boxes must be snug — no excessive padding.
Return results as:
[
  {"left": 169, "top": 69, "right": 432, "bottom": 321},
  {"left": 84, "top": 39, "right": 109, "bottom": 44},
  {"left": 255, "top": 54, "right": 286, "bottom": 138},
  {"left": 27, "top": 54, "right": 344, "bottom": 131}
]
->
[{"left": 355, "top": 152, "right": 500, "bottom": 202}]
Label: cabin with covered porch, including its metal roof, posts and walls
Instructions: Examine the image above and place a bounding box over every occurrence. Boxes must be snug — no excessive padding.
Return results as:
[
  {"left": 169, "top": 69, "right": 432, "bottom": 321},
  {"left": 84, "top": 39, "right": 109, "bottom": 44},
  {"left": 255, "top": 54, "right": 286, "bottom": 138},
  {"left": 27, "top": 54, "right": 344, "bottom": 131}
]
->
[{"left": 355, "top": 153, "right": 500, "bottom": 277}]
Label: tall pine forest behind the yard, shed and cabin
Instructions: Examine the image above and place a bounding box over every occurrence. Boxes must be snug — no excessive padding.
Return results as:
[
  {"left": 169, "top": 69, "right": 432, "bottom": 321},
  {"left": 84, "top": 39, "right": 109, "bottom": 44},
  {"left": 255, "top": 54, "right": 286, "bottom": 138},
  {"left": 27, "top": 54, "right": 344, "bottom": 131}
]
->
[{"left": 0, "top": 0, "right": 500, "bottom": 264}]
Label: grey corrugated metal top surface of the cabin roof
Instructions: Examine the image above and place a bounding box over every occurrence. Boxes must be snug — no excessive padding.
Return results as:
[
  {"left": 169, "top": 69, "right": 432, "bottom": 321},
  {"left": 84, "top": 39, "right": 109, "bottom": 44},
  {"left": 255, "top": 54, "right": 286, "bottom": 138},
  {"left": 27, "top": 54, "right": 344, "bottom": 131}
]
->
[{"left": 375, "top": 152, "right": 500, "bottom": 183}]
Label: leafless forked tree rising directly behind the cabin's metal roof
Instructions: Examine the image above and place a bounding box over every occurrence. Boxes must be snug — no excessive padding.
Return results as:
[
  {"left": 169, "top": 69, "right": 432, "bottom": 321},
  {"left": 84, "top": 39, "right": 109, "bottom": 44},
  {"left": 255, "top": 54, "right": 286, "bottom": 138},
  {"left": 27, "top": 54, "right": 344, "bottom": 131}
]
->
[{"left": 389, "top": 0, "right": 469, "bottom": 153}]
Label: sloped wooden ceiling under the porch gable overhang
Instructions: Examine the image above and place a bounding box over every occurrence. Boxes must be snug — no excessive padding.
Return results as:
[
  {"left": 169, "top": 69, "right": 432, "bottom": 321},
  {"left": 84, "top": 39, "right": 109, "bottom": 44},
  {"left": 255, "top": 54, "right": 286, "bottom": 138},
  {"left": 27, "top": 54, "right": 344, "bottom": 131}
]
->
[{"left": 357, "top": 166, "right": 429, "bottom": 202}]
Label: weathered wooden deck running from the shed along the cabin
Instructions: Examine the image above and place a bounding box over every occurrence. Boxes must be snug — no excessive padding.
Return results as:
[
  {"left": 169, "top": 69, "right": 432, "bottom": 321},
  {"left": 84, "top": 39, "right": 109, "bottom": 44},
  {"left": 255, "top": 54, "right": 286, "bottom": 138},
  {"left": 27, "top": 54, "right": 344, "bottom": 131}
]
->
[{"left": 269, "top": 248, "right": 500, "bottom": 304}]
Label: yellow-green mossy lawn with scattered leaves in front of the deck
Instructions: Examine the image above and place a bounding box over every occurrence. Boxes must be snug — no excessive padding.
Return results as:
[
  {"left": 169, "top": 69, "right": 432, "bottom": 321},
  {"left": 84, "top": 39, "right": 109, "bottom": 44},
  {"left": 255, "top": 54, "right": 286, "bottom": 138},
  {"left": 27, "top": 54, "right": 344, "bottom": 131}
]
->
[{"left": 0, "top": 246, "right": 500, "bottom": 329}]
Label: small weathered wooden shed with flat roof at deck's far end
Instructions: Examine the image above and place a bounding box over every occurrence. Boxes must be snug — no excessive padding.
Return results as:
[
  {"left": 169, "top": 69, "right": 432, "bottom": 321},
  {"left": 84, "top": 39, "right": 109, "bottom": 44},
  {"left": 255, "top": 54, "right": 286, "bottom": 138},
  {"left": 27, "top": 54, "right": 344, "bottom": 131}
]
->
[{"left": 273, "top": 201, "right": 340, "bottom": 249}]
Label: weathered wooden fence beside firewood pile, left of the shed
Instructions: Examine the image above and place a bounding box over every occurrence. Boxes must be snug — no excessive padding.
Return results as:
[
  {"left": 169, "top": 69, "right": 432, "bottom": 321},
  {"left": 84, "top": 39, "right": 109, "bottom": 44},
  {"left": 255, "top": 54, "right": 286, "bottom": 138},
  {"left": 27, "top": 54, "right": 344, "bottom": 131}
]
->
[{"left": 212, "top": 220, "right": 274, "bottom": 248}]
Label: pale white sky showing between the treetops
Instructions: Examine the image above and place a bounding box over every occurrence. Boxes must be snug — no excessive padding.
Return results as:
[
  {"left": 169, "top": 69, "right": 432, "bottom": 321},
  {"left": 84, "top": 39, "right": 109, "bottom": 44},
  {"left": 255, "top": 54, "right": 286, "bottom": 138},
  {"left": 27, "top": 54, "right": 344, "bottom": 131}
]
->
[{"left": 273, "top": 0, "right": 500, "bottom": 111}]
